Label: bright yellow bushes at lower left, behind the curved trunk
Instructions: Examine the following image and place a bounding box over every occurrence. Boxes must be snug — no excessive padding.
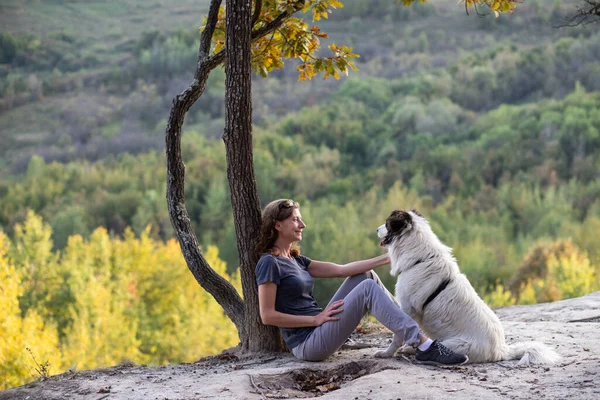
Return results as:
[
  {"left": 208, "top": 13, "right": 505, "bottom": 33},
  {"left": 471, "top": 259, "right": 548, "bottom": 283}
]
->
[{"left": 0, "top": 212, "right": 239, "bottom": 389}]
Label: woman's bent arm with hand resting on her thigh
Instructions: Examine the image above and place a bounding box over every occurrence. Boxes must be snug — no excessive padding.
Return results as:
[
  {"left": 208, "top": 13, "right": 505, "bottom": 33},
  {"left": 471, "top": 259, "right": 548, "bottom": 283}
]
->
[{"left": 258, "top": 282, "right": 344, "bottom": 328}]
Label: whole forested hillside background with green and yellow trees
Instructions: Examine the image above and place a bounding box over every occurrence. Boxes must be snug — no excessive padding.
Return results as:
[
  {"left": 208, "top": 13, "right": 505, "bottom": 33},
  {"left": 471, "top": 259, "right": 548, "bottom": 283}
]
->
[{"left": 0, "top": 0, "right": 600, "bottom": 388}]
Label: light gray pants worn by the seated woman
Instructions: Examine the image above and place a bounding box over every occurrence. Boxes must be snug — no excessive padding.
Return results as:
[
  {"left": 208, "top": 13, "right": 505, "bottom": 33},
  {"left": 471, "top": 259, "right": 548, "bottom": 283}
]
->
[{"left": 292, "top": 271, "right": 421, "bottom": 361}]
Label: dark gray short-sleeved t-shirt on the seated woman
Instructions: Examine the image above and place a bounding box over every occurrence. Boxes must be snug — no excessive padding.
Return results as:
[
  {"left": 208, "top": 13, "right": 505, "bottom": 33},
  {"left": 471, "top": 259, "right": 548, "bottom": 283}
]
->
[{"left": 256, "top": 254, "right": 323, "bottom": 349}]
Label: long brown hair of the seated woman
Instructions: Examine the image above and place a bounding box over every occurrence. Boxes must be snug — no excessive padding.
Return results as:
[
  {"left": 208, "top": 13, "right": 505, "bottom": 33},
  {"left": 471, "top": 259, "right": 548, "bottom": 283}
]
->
[{"left": 256, "top": 199, "right": 300, "bottom": 257}]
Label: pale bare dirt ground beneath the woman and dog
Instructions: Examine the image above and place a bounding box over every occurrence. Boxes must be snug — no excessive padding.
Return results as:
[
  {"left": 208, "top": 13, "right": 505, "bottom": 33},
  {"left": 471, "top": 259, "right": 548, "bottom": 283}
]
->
[{"left": 0, "top": 292, "right": 600, "bottom": 400}]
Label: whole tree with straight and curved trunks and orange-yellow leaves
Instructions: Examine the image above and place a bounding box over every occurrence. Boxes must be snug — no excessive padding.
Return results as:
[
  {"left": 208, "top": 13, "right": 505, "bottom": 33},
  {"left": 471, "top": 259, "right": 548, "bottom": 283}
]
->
[{"left": 165, "top": 0, "right": 518, "bottom": 351}]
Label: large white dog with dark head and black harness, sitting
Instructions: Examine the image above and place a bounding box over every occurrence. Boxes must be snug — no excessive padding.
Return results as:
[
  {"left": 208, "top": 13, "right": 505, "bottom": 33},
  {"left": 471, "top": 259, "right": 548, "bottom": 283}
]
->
[{"left": 376, "top": 210, "right": 561, "bottom": 365}]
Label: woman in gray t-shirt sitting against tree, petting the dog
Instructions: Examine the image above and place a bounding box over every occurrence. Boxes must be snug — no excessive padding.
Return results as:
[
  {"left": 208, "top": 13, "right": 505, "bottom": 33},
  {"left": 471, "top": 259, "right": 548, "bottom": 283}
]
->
[{"left": 256, "top": 199, "right": 468, "bottom": 365}]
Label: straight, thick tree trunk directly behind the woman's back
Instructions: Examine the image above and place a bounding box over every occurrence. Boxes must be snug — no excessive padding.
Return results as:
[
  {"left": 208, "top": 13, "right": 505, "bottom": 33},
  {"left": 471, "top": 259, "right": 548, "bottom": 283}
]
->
[{"left": 223, "top": 0, "right": 282, "bottom": 352}]
